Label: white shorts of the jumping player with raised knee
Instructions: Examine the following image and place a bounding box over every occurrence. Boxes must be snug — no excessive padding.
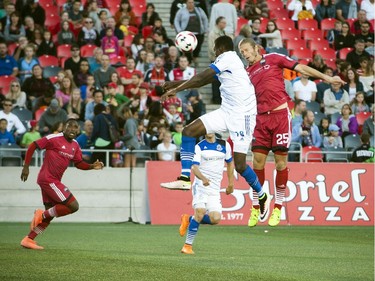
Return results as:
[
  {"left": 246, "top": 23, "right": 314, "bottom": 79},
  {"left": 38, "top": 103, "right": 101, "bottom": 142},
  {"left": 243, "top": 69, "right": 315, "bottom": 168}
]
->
[{"left": 199, "top": 108, "right": 256, "bottom": 154}]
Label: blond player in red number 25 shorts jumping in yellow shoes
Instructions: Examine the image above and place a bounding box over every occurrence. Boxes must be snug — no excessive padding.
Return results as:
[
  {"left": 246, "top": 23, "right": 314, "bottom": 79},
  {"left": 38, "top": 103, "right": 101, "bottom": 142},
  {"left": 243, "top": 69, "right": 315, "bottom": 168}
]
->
[{"left": 239, "top": 39, "right": 345, "bottom": 227}]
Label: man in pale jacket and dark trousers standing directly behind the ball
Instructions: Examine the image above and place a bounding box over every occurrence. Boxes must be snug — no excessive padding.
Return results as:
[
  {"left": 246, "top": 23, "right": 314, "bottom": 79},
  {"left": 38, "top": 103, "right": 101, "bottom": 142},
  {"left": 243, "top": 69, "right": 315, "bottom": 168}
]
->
[{"left": 174, "top": 0, "right": 209, "bottom": 63}]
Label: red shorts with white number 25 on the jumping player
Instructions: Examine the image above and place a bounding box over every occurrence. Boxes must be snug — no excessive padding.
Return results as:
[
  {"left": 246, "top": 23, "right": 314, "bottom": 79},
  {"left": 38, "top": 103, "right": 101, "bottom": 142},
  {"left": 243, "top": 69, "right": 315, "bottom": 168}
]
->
[{"left": 251, "top": 108, "right": 292, "bottom": 152}]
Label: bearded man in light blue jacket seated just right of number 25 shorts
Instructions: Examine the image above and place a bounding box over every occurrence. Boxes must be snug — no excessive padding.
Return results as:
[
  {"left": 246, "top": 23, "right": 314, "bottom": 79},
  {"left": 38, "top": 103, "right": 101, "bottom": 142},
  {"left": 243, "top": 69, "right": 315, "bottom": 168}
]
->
[{"left": 292, "top": 110, "right": 322, "bottom": 147}]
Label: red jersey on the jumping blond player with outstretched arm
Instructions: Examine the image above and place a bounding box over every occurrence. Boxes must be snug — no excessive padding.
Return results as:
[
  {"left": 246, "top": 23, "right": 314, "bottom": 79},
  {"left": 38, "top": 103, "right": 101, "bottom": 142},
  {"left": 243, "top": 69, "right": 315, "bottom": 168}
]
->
[{"left": 246, "top": 53, "right": 298, "bottom": 114}]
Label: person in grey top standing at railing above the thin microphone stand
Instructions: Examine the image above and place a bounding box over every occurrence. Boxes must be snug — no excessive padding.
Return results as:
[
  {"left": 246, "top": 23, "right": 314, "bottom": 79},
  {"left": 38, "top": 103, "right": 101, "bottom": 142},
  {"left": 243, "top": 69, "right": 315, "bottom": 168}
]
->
[{"left": 121, "top": 106, "right": 140, "bottom": 167}]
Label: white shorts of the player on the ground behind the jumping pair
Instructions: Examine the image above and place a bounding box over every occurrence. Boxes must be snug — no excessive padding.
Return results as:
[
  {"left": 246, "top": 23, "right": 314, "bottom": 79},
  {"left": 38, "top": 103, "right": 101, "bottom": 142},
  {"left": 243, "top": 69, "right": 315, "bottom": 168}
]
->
[{"left": 192, "top": 181, "right": 222, "bottom": 214}]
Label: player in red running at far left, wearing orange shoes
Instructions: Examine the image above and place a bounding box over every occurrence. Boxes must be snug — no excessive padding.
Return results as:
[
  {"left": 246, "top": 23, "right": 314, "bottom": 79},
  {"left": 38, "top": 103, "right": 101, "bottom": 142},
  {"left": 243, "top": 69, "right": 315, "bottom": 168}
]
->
[{"left": 21, "top": 119, "right": 104, "bottom": 250}]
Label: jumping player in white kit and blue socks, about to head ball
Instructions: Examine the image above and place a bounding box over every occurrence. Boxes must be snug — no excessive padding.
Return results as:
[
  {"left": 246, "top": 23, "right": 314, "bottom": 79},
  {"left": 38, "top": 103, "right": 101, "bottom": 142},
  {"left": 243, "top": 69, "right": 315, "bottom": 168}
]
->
[{"left": 161, "top": 36, "right": 268, "bottom": 221}]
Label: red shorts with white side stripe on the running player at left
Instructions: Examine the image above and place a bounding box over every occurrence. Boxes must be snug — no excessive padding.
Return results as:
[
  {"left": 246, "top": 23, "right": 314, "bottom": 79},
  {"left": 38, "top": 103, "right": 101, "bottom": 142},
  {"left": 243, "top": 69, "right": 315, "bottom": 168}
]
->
[{"left": 38, "top": 181, "right": 73, "bottom": 205}]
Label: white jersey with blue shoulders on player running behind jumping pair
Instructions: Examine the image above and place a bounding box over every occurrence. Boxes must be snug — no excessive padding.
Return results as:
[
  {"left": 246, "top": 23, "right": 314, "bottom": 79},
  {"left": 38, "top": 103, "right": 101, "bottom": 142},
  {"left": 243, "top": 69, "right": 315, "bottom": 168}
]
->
[{"left": 193, "top": 139, "right": 232, "bottom": 192}]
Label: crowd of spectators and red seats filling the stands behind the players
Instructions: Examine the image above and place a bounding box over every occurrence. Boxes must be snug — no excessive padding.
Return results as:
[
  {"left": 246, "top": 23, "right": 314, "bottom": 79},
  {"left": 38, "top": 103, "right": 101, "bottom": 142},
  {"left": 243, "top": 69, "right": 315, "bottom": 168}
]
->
[{"left": 0, "top": 0, "right": 375, "bottom": 167}]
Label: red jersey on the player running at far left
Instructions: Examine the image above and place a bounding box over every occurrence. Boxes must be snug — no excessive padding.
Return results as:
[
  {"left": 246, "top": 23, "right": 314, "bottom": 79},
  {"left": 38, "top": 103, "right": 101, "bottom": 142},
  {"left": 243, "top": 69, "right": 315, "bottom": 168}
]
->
[{"left": 35, "top": 133, "right": 82, "bottom": 184}]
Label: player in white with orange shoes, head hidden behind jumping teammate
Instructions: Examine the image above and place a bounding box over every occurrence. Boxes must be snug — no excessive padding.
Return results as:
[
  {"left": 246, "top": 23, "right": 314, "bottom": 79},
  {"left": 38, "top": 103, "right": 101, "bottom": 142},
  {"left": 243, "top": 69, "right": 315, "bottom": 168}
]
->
[{"left": 180, "top": 134, "right": 234, "bottom": 254}]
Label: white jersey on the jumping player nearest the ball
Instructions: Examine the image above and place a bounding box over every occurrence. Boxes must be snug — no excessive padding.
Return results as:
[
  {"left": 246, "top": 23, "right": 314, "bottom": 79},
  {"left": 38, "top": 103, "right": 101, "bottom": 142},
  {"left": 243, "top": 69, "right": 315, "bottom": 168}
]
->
[{"left": 210, "top": 51, "right": 258, "bottom": 114}]
